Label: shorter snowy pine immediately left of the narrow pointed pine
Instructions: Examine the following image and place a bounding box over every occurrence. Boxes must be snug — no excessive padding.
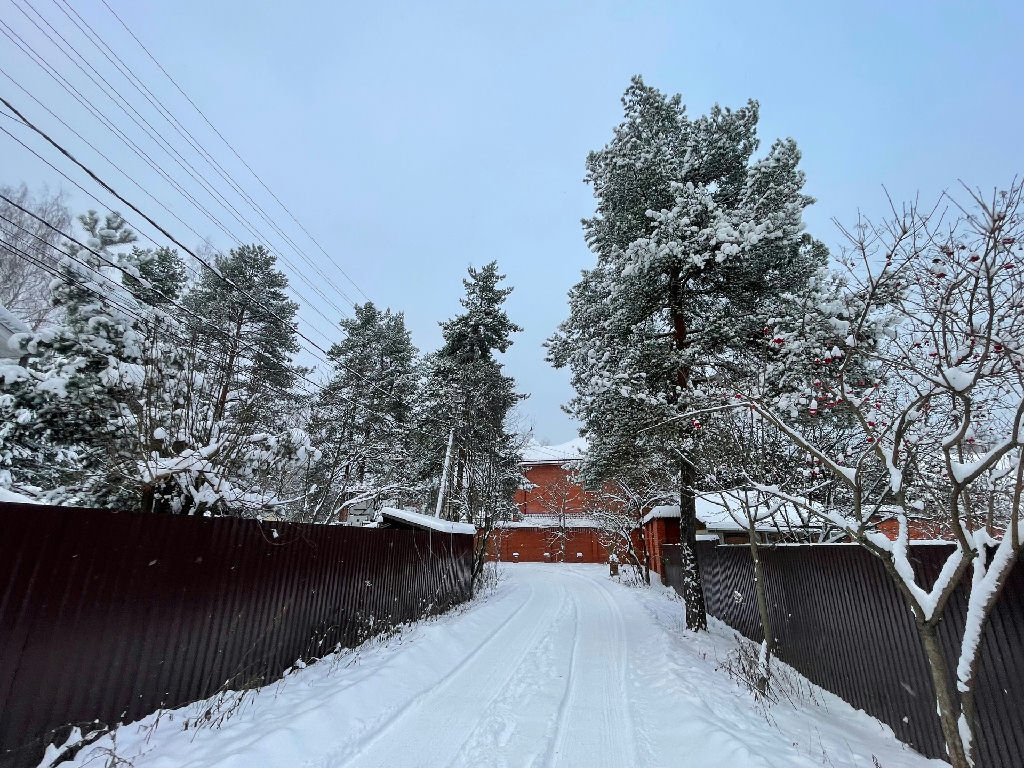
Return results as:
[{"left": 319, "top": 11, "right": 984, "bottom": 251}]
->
[{"left": 307, "top": 301, "right": 418, "bottom": 521}]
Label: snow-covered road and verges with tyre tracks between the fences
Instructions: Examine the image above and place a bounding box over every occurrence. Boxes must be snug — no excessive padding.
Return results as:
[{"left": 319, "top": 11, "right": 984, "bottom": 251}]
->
[{"left": 49, "top": 563, "right": 946, "bottom": 768}]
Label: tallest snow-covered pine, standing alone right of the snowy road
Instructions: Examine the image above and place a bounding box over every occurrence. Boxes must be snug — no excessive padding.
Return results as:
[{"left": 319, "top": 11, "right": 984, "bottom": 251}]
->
[{"left": 549, "top": 77, "right": 814, "bottom": 629}]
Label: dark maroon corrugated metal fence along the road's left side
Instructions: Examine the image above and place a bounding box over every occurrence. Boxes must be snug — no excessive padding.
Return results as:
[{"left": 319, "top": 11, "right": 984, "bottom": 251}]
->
[{"left": 0, "top": 504, "right": 473, "bottom": 768}]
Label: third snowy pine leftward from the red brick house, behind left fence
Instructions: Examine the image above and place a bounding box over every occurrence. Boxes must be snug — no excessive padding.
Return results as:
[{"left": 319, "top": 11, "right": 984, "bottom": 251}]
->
[{"left": 164, "top": 245, "right": 312, "bottom": 514}]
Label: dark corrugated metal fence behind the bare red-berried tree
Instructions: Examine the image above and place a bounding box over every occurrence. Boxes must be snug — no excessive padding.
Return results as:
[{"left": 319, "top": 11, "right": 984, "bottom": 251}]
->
[{"left": 663, "top": 542, "right": 1024, "bottom": 768}]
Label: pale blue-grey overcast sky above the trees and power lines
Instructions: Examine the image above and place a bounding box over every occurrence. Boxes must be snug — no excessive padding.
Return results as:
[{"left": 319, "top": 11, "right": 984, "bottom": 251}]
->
[{"left": 0, "top": 0, "right": 1024, "bottom": 442}]
